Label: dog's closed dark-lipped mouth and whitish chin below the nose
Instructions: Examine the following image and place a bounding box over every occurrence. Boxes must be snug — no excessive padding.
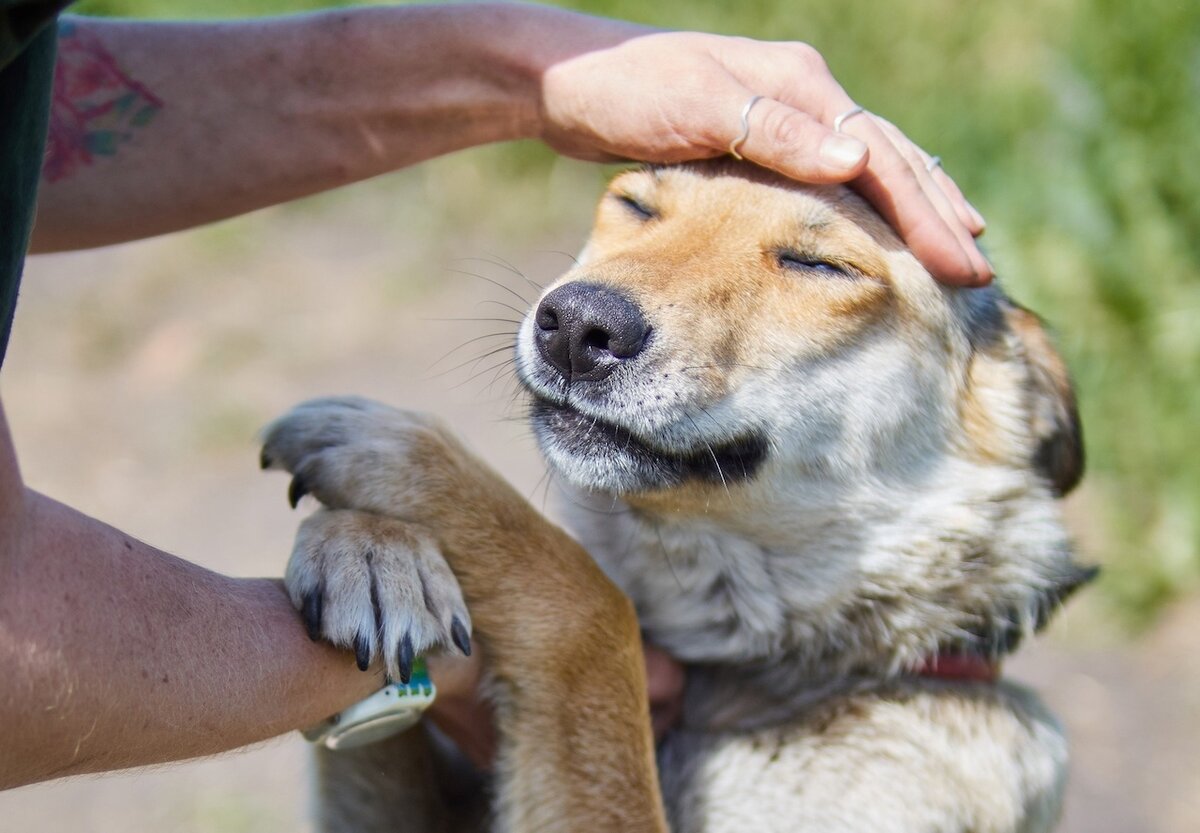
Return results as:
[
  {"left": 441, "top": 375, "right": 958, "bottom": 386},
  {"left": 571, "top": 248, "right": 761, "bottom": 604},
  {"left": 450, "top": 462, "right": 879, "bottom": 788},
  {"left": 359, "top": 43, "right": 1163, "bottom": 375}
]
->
[{"left": 530, "top": 391, "right": 767, "bottom": 495}]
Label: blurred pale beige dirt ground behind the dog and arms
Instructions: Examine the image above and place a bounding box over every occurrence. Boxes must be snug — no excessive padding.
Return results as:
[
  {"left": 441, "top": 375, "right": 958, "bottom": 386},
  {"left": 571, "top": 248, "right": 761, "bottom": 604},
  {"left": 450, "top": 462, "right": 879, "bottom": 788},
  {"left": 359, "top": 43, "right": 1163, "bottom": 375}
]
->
[{"left": 0, "top": 171, "right": 1200, "bottom": 833}]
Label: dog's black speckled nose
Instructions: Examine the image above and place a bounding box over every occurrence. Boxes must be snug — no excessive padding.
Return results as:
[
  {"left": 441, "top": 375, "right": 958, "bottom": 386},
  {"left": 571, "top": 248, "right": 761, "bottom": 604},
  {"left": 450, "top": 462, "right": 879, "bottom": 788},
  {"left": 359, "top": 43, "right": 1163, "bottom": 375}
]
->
[{"left": 534, "top": 281, "right": 650, "bottom": 382}]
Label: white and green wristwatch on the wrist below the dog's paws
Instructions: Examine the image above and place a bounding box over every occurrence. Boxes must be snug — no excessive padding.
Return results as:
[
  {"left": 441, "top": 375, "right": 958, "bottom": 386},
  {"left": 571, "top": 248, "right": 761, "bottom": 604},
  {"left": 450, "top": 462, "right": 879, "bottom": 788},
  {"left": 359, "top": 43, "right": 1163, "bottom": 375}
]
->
[{"left": 302, "top": 660, "right": 438, "bottom": 749}]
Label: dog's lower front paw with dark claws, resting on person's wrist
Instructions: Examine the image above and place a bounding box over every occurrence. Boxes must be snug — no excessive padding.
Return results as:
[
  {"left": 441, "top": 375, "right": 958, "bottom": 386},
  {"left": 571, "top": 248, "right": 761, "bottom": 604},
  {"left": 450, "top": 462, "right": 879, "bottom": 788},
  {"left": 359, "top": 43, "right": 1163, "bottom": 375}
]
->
[{"left": 284, "top": 509, "right": 470, "bottom": 683}]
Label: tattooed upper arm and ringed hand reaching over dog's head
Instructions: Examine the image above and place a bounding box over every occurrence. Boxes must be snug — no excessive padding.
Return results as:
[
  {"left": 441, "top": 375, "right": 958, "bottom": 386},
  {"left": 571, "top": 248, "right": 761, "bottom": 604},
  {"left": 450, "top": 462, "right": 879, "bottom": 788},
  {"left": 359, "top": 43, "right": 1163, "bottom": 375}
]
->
[{"left": 34, "top": 4, "right": 991, "bottom": 283}]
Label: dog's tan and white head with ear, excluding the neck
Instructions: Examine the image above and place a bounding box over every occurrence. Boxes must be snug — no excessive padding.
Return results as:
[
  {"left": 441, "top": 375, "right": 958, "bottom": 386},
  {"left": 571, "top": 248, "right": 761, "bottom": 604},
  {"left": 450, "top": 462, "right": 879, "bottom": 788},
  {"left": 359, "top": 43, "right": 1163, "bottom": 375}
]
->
[{"left": 518, "top": 163, "right": 1082, "bottom": 501}]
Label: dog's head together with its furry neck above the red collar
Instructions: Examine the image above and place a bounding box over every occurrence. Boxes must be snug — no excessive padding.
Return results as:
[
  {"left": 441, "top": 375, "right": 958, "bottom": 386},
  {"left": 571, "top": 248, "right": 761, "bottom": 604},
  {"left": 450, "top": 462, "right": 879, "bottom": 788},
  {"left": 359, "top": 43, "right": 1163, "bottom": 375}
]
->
[{"left": 517, "top": 162, "right": 1082, "bottom": 664}]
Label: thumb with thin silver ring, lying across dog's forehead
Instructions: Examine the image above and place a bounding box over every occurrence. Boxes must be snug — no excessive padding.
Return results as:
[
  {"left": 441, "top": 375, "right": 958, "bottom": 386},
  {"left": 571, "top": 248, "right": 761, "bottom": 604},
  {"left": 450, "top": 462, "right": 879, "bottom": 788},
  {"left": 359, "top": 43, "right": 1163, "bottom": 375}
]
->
[{"left": 737, "top": 98, "right": 869, "bottom": 184}]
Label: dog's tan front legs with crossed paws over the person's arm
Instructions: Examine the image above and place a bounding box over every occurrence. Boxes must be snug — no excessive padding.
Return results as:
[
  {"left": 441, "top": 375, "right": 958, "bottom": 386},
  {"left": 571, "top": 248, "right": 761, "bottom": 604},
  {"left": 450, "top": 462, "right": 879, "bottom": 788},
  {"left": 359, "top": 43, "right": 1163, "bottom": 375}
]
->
[{"left": 263, "top": 398, "right": 665, "bottom": 831}]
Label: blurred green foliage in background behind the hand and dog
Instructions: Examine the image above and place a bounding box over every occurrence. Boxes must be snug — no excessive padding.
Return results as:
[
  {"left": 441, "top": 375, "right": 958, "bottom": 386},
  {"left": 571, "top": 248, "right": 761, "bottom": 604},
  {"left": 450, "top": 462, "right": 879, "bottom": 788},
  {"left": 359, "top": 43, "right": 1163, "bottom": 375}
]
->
[{"left": 70, "top": 0, "right": 1200, "bottom": 622}]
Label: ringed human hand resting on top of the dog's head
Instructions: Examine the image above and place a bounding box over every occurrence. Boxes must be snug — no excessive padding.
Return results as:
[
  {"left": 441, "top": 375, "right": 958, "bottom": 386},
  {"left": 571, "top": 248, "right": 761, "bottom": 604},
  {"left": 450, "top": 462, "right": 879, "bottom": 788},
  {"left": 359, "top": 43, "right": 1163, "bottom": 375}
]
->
[{"left": 541, "top": 28, "right": 994, "bottom": 286}]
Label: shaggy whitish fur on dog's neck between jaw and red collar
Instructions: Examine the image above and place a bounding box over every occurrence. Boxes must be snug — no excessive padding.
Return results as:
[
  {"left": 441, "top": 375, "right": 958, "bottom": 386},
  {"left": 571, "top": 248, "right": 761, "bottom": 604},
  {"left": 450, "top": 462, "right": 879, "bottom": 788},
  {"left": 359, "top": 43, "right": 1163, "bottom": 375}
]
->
[{"left": 556, "top": 457, "right": 1070, "bottom": 673}]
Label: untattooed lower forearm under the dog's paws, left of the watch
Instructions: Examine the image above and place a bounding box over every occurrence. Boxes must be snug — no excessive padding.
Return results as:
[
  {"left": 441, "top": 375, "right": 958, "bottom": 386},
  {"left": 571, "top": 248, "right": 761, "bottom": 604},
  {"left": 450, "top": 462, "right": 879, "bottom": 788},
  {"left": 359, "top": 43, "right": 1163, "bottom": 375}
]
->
[{"left": 0, "top": 482, "right": 380, "bottom": 789}]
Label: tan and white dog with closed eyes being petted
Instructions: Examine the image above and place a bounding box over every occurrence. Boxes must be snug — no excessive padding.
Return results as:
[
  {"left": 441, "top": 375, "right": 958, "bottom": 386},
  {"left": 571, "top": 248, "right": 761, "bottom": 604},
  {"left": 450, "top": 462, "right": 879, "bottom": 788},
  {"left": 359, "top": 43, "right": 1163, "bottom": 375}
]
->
[{"left": 265, "top": 161, "right": 1094, "bottom": 833}]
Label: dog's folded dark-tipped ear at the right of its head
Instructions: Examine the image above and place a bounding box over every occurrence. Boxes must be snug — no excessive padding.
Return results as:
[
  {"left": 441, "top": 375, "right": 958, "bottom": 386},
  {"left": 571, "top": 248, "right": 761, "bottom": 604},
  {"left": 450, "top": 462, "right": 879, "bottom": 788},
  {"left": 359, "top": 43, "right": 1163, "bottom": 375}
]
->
[{"left": 1000, "top": 298, "right": 1084, "bottom": 495}]
